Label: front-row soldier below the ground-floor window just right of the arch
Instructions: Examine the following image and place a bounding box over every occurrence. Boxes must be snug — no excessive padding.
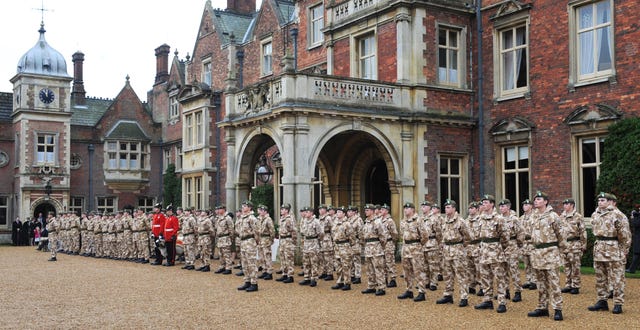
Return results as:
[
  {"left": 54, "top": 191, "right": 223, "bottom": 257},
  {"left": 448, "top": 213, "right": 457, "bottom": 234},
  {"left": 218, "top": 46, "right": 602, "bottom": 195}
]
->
[{"left": 436, "top": 199, "right": 470, "bottom": 307}]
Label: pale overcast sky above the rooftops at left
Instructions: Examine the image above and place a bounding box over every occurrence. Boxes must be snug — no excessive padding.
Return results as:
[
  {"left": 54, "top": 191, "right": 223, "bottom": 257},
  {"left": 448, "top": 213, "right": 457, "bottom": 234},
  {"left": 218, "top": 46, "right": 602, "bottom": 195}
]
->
[{"left": 0, "top": 0, "right": 232, "bottom": 101}]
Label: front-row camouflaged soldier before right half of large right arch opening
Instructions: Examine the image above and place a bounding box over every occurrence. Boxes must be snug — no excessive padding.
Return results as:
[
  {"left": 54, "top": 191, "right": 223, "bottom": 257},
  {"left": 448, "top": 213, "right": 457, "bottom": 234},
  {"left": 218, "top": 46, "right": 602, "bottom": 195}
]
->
[{"left": 362, "top": 204, "right": 389, "bottom": 296}]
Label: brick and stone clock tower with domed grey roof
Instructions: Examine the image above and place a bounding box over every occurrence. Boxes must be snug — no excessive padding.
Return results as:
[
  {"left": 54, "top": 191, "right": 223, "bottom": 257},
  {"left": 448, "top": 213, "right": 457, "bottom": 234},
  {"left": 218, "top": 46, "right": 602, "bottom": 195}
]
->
[{"left": 11, "top": 23, "right": 73, "bottom": 218}]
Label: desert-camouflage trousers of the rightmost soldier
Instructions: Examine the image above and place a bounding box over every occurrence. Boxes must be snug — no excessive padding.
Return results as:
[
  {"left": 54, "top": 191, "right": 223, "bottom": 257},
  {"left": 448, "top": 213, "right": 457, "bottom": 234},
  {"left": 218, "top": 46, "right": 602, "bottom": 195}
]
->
[{"left": 593, "top": 261, "right": 626, "bottom": 305}]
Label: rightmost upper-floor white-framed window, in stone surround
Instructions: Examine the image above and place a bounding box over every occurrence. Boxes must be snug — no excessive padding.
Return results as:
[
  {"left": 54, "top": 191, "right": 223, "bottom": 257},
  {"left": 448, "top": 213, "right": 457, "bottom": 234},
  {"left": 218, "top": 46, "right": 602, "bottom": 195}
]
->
[{"left": 568, "top": 0, "right": 616, "bottom": 88}]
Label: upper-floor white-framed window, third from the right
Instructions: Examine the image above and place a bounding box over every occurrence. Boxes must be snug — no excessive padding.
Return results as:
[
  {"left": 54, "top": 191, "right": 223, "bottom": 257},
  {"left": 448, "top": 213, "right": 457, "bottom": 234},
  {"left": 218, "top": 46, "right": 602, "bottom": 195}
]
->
[{"left": 436, "top": 24, "right": 466, "bottom": 87}]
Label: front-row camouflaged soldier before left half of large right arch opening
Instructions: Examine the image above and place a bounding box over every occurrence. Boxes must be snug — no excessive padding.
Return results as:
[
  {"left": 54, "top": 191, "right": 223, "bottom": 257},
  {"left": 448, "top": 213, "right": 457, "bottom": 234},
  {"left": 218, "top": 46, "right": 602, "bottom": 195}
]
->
[{"left": 331, "top": 206, "right": 356, "bottom": 291}]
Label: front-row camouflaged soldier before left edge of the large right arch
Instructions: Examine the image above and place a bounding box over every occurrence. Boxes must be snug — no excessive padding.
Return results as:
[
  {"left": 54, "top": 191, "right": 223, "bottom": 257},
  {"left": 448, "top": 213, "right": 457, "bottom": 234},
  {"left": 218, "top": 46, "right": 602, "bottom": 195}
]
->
[{"left": 298, "top": 206, "right": 324, "bottom": 286}]
